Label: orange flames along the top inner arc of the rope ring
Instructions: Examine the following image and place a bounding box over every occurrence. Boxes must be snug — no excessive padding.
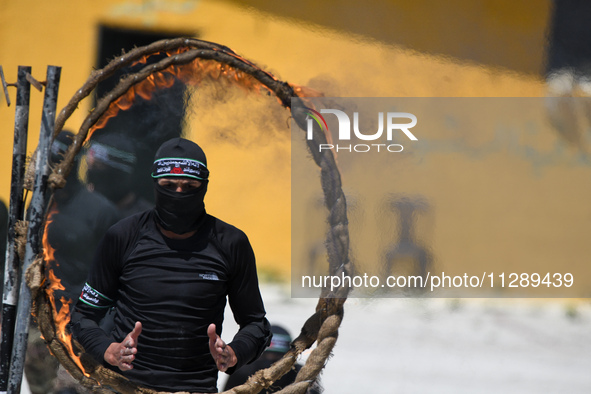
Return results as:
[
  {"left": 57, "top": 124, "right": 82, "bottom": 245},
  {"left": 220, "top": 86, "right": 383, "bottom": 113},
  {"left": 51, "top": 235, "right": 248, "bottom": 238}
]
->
[{"left": 85, "top": 48, "right": 270, "bottom": 142}]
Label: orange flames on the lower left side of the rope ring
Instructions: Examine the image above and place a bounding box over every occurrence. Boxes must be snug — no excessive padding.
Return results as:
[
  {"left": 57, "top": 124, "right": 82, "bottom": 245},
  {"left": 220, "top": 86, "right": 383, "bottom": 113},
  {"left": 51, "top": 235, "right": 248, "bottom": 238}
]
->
[{"left": 42, "top": 203, "right": 90, "bottom": 376}]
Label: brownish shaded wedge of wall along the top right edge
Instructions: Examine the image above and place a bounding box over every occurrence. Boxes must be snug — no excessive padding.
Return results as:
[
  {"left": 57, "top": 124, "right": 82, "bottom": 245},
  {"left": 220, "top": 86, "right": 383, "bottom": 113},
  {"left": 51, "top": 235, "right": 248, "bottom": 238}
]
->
[{"left": 228, "top": 0, "right": 551, "bottom": 74}]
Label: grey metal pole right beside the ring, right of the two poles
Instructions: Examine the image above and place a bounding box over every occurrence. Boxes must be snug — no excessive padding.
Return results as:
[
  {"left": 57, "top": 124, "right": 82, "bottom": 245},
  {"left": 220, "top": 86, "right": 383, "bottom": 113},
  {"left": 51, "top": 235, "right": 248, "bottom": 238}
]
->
[{"left": 8, "top": 66, "right": 61, "bottom": 394}]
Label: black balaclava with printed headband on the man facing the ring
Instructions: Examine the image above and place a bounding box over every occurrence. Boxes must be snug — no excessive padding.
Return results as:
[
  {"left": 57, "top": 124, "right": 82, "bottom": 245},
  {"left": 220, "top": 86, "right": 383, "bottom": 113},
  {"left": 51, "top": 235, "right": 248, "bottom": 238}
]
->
[{"left": 152, "top": 138, "right": 209, "bottom": 234}]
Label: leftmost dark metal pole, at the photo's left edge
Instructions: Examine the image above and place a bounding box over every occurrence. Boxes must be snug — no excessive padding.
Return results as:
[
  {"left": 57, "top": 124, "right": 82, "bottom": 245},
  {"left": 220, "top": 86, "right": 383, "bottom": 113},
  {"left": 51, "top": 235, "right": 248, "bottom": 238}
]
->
[{"left": 0, "top": 66, "right": 31, "bottom": 393}]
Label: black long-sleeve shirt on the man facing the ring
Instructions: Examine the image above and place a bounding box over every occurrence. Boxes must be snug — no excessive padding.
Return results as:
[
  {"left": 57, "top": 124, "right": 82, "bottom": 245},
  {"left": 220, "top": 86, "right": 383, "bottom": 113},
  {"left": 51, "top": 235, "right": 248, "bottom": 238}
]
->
[{"left": 71, "top": 210, "right": 270, "bottom": 392}]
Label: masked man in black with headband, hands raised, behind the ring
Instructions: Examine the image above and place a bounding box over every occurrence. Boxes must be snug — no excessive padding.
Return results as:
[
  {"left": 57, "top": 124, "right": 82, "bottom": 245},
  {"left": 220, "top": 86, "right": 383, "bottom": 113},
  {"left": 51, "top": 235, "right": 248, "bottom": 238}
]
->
[{"left": 71, "top": 138, "right": 271, "bottom": 393}]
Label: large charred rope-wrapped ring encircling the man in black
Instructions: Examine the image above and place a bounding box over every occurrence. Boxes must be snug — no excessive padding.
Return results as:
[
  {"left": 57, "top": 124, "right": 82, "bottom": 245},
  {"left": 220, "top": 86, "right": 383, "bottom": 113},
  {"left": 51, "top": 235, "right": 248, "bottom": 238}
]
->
[{"left": 30, "top": 38, "right": 353, "bottom": 394}]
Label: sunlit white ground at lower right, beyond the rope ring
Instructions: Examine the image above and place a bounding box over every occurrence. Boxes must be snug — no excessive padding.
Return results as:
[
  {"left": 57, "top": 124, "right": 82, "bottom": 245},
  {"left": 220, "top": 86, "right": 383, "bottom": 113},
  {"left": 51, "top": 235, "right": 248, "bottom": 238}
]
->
[{"left": 220, "top": 285, "right": 591, "bottom": 394}]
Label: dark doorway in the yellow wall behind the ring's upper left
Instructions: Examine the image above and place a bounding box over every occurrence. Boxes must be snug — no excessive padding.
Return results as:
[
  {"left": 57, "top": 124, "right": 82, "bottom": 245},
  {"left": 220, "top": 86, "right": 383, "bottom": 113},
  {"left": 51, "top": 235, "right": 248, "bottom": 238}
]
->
[{"left": 91, "top": 26, "right": 195, "bottom": 212}]
